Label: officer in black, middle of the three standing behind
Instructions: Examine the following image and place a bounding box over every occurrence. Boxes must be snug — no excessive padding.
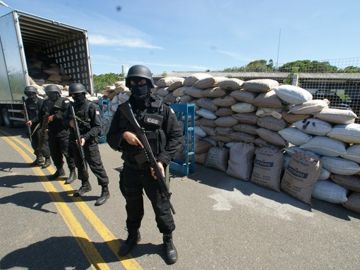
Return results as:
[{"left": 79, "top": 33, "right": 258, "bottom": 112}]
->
[{"left": 41, "top": 84, "right": 77, "bottom": 180}]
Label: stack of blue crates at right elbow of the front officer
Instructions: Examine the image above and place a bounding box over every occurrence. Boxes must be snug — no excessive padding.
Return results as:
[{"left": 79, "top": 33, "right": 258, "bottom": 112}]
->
[{"left": 170, "top": 103, "right": 195, "bottom": 176}]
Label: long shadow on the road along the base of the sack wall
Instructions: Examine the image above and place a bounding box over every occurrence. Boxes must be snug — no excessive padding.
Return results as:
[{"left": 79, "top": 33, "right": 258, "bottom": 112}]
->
[{"left": 188, "top": 164, "right": 360, "bottom": 220}]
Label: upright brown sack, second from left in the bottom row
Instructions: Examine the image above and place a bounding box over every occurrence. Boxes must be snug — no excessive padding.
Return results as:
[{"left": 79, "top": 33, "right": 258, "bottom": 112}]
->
[{"left": 226, "top": 143, "right": 255, "bottom": 181}]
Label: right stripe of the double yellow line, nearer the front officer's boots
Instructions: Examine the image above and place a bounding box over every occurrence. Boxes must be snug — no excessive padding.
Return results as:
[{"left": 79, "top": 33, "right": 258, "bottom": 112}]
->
[{"left": 3, "top": 132, "right": 142, "bottom": 270}]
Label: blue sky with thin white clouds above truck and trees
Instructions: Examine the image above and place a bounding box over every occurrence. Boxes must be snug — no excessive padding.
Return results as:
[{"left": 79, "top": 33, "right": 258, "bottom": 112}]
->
[{"left": 0, "top": 0, "right": 360, "bottom": 74}]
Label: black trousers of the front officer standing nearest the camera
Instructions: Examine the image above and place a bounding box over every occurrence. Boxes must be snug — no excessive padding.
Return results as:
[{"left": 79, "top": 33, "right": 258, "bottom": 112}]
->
[{"left": 120, "top": 166, "right": 175, "bottom": 234}]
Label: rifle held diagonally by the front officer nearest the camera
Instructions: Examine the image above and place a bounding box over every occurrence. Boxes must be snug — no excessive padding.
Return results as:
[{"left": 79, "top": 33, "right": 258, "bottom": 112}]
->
[{"left": 119, "top": 102, "right": 175, "bottom": 214}]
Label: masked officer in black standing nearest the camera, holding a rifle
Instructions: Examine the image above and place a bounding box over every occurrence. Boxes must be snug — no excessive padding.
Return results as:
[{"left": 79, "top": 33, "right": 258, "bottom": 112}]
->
[{"left": 107, "top": 65, "right": 182, "bottom": 264}]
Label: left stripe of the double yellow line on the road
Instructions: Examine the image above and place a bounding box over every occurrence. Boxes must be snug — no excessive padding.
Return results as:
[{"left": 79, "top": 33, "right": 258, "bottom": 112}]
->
[{"left": 2, "top": 137, "right": 110, "bottom": 270}]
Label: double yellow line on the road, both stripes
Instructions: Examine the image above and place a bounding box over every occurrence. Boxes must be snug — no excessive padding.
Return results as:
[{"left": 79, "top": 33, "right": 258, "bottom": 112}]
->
[{"left": 0, "top": 131, "right": 142, "bottom": 270}]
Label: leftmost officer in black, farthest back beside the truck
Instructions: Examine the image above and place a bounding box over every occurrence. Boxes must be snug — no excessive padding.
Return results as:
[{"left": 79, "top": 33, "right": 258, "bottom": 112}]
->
[{"left": 24, "top": 86, "right": 51, "bottom": 168}]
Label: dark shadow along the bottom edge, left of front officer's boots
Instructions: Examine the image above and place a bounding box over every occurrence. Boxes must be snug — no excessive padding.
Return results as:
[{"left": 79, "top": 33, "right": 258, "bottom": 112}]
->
[{"left": 0, "top": 236, "right": 169, "bottom": 270}]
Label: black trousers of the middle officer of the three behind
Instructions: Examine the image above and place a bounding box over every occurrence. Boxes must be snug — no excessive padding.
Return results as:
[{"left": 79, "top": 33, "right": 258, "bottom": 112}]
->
[{"left": 49, "top": 133, "right": 75, "bottom": 170}]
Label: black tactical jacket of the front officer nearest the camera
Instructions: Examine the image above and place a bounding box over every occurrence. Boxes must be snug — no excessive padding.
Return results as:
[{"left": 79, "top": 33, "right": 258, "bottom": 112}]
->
[{"left": 107, "top": 97, "right": 182, "bottom": 169}]
